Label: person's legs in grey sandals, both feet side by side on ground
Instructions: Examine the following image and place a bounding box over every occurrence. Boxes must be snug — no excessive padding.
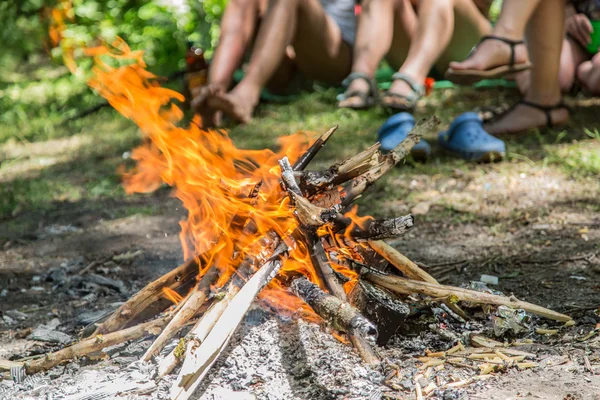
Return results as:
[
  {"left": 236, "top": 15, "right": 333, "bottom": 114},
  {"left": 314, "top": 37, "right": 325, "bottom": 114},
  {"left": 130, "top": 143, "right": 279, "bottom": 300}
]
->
[{"left": 338, "top": 0, "right": 492, "bottom": 111}]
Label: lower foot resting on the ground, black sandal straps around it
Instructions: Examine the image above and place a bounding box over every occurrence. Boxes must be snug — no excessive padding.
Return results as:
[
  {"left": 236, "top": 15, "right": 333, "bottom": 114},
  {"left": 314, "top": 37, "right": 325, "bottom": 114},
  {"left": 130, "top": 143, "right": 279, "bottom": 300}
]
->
[{"left": 484, "top": 104, "right": 569, "bottom": 135}]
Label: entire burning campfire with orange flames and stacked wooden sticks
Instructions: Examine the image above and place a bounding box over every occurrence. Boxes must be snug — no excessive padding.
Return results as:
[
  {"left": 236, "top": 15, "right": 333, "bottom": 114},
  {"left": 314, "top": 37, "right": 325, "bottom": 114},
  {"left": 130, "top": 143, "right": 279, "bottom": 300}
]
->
[{"left": 10, "top": 41, "right": 570, "bottom": 399}]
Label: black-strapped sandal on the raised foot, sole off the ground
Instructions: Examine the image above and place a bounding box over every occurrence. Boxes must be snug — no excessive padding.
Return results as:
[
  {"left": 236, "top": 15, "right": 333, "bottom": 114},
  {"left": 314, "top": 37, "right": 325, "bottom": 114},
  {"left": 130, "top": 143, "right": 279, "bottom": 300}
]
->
[{"left": 444, "top": 35, "right": 531, "bottom": 85}]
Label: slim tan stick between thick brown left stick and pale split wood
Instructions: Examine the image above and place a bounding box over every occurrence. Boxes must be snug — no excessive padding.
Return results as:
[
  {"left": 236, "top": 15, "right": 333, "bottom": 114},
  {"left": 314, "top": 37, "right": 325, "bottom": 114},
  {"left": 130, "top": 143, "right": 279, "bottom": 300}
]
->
[{"left": 142, "top": 265, "right": 219, "bottom": 361}]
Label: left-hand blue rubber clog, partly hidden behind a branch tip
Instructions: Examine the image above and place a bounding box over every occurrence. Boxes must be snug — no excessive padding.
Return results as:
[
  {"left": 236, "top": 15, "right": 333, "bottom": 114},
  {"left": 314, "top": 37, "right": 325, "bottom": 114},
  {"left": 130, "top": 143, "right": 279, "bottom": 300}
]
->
[{"left": 377, "top": 112, "right": 431, "bottom": 161}]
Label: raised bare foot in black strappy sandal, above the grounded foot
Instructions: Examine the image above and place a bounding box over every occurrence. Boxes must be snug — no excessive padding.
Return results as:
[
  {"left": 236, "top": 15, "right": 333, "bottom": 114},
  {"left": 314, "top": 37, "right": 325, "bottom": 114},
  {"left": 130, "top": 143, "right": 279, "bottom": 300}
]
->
[{"left": 450, "top": 39, "right": 528, "bottom": 71}]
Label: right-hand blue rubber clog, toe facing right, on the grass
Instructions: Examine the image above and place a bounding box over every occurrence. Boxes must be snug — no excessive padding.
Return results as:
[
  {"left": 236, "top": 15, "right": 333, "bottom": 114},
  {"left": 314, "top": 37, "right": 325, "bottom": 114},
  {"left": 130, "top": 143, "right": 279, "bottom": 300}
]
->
[{"left": 438, "top": 112, "right": 506, "bottom": 162}]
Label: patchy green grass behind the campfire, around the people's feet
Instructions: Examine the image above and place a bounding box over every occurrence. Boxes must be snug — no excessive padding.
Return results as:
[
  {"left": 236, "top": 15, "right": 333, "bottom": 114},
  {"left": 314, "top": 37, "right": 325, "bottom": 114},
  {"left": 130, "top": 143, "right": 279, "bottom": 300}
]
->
[{"left": 0, "top": 61, "right": 600, "bottom": 225}]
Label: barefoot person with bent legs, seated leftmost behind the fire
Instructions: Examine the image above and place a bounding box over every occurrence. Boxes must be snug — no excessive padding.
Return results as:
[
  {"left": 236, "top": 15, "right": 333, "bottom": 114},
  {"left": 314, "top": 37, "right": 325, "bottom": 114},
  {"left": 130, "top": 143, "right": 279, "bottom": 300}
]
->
[{"left": 191, "top": 0, "right": 356, "bottom": 126}]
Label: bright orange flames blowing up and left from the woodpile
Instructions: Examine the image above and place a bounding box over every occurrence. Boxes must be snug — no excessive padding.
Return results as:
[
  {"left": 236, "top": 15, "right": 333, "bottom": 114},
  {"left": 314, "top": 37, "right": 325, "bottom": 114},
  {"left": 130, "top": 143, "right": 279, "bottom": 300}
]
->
[{"left": 65, "top": 34, "right": 378, "bottom": 321}]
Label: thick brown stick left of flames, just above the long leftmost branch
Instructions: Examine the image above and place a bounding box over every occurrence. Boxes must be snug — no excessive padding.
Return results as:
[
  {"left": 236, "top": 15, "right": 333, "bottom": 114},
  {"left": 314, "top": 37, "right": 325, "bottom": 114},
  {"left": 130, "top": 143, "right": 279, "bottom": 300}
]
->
[{"left": 91, "top": 258, "right": 199, "bottom": 336}]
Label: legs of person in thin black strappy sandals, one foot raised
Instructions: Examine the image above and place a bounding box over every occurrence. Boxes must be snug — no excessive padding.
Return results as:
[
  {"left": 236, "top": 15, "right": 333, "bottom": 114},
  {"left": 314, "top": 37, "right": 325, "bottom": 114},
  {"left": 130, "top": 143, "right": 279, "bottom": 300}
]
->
[{"left": 446, "top": 0, "right": 569, "bottom": 135}]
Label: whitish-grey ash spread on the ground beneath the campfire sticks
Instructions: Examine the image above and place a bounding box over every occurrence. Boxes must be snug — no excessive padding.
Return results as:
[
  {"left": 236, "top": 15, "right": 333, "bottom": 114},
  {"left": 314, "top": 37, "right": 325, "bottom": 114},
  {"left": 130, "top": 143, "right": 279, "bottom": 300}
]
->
[{"left": 0, "top": 308, "right": 389, "bottom": 400}]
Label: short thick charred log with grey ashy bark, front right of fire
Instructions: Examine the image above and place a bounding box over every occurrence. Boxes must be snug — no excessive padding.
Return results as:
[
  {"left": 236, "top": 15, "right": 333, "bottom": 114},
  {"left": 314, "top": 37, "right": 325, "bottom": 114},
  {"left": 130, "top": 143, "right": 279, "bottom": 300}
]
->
[{"left": 291, "top": 277, "right": 377, "bottom": 339}]
